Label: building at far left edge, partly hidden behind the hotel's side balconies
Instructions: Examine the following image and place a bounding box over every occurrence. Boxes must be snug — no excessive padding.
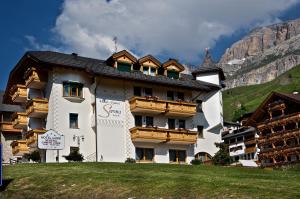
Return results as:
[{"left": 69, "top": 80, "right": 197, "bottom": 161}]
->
[{"left": 0, "top": 92, "right": 24, "bottom": 163}]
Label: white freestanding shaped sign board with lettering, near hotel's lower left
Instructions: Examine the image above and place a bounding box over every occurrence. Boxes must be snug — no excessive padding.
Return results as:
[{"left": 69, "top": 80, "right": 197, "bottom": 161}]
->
[{"left": 38, "top": 130, "right": 65, "bottom": 150}]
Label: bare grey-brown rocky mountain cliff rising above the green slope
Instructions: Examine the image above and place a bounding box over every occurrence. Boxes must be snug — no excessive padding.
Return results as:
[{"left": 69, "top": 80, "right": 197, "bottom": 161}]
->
[{"left": 218, "top": 19, "right": 300, "bottom": 88}]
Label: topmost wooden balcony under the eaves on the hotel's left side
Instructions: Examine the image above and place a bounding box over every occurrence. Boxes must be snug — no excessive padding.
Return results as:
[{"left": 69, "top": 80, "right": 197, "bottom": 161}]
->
[{"left": 25, "top": 67, "right": 47, "bottom": 89}]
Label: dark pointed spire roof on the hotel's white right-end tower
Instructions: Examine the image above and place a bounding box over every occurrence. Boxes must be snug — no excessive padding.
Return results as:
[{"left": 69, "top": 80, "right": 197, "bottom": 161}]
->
[{"left": 192, "top": 50, "right": 225, "bottom": 80}]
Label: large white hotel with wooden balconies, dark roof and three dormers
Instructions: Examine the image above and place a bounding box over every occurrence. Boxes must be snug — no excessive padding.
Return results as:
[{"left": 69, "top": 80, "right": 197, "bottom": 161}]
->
[{"left": 4, "top": 51, "right": 224, "bottom": 163}]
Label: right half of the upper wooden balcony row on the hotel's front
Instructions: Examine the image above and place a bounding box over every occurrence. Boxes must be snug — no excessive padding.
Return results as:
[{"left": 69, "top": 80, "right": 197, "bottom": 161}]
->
[{"left": 166, "top": 101, "right": 196, "bottom": 117}]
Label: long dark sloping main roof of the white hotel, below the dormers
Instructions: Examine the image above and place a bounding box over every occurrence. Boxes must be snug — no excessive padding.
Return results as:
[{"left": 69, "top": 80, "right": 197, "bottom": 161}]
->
[{"left": 23, "top": 51, "right": 221, "bottom": 91}]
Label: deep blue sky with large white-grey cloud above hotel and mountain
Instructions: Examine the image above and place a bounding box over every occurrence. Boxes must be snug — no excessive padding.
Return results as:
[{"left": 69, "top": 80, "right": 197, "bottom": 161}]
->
[{"left": 0, "top": 0, "right": 300, "bottom": 89}]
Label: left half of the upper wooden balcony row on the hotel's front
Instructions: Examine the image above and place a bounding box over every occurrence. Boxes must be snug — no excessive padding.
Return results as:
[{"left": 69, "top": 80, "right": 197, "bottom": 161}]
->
[{"left": 129, "top": 97, "right": 166, "bottom": 114}]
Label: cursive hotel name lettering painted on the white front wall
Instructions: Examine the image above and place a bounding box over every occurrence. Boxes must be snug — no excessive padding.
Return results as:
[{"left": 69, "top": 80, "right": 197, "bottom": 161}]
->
[{"left": 97, "top": 99, "right": 125, "bottom": 121}]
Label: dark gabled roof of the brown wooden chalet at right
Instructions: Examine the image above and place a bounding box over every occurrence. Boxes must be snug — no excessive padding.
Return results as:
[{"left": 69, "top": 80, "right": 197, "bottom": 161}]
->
[{"left": 245, "top": 91, "right": 300, "bottom": 125}]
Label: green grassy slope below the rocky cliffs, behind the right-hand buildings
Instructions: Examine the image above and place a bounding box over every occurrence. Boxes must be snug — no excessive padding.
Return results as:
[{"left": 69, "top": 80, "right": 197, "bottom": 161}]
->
[{"left": 223, "top": 65, "right": 300, "bottom": 121}]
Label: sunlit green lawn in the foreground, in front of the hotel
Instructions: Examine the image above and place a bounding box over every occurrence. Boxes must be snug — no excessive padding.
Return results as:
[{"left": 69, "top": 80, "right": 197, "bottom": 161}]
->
[{"left": 0, "top": 163, "right": 300, "bottom": 199}]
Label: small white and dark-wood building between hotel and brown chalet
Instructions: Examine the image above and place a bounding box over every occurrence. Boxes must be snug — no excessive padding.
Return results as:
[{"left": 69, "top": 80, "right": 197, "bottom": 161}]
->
[{"left": 222, "top": 122, "right": 259, "bottom": 162}]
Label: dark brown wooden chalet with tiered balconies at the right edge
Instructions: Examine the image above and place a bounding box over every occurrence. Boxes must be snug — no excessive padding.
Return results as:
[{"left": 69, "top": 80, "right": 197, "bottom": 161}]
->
[{"left": 246, "top": 92, "right": 300, "bottom": 166}]
